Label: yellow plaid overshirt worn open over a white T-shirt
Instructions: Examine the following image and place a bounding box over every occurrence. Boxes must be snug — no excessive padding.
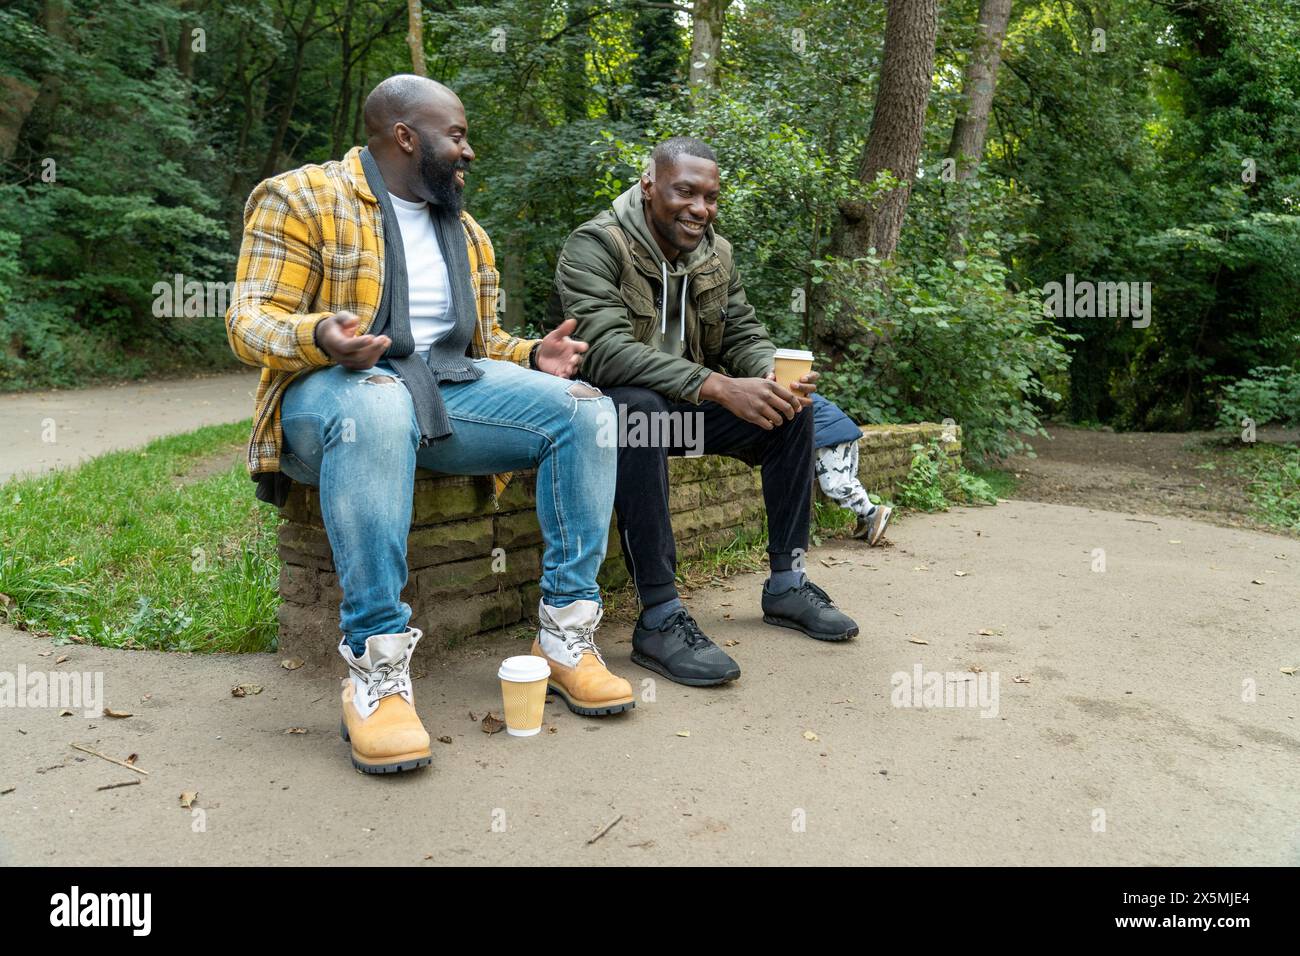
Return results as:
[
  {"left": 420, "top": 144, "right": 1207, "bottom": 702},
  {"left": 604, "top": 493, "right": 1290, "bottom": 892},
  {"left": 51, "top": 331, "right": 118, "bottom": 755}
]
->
[{"left": 226, "top": 147, "right": 536, "bottom": 502}]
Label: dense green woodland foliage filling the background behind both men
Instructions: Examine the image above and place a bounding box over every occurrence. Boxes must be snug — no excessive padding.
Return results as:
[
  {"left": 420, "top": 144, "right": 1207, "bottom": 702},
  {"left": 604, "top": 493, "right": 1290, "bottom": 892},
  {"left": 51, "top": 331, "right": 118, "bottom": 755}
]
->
[{"left": 0, "top": 0, "right": 1300, "bottom": 442}]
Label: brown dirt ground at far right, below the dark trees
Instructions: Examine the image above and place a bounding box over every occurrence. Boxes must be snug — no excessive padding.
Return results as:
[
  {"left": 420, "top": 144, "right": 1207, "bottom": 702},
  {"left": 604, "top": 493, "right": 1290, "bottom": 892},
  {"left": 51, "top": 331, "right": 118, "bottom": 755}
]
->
[{"left": 1005, "top": 425, "right": 1300, "bottom": 533}]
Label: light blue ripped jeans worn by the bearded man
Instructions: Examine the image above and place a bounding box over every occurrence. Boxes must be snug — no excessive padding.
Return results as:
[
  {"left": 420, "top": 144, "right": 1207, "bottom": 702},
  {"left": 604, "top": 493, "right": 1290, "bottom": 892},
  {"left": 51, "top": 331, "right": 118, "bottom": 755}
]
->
[{"left": 281, "top": 359, "right": 618, "bottom": 652}]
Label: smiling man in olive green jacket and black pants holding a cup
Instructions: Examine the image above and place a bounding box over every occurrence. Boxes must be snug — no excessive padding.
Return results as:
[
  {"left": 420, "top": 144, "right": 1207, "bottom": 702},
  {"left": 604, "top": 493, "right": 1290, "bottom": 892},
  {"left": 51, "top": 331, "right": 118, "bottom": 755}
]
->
[{"left": 547, "top": 137, "right": 858, "bottom": 685}]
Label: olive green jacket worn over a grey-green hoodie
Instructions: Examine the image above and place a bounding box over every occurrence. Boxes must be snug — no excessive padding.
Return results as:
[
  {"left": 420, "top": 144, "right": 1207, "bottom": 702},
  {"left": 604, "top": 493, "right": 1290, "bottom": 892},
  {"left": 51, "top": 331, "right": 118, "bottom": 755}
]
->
[{"left": 546, "top": 183, "right": 776, "bottom": 403}]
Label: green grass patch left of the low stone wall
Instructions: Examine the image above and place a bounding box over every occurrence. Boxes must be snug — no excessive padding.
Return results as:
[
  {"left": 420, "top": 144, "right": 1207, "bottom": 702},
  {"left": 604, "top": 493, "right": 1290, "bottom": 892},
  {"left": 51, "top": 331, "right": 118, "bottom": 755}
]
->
[{"left": 0, "top": 421, "right": 280, "bottom": 652}]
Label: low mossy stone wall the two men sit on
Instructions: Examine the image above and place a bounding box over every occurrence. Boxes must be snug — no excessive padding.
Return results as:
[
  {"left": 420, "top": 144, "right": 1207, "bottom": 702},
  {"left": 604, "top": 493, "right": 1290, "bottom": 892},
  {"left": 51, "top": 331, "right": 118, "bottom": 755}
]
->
[{"left": 280, "top": 423, "right": 961, "bottom": 666}]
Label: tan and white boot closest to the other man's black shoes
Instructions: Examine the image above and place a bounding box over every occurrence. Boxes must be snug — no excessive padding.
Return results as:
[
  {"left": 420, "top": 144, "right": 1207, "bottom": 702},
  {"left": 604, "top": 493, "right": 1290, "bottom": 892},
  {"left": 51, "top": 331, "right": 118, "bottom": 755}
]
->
[{"left": 533, "top": 601, "right": 637, "bottom": 717}]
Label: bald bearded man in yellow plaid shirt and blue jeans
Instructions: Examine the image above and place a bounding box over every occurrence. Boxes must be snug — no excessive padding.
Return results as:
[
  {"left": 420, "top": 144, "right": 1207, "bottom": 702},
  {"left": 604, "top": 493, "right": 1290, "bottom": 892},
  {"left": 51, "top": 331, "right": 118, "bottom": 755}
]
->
[{"left": 226, "top": 74, "right": 634, "bottom": 774}]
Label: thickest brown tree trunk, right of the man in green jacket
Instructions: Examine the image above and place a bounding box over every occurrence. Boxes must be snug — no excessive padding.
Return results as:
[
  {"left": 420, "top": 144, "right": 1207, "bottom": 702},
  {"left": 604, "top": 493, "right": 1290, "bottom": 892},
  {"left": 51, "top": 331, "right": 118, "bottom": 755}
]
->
[{"left": 833, "top": 0, "right": 939, "bottom": 259}]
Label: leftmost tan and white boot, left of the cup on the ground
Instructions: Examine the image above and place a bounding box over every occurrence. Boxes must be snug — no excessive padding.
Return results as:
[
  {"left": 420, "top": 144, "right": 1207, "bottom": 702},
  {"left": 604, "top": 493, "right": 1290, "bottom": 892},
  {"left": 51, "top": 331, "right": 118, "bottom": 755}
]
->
[{"left": 338, "top": 627, "right": 433, "bottom": 774}]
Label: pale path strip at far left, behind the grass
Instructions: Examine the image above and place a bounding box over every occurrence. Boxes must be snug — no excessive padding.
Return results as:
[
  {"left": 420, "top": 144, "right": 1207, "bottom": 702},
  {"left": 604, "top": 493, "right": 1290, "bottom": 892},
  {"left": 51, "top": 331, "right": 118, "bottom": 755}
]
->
[{"left": 0, "top": 369, "right": 257, "bottom": 481}]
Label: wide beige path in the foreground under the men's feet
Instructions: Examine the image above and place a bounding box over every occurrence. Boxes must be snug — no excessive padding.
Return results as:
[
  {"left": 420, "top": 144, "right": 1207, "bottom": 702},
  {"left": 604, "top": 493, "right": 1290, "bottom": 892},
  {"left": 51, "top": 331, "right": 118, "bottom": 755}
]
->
[{"left": 0, "top": 501, "right": 1300, "bottom": 865}]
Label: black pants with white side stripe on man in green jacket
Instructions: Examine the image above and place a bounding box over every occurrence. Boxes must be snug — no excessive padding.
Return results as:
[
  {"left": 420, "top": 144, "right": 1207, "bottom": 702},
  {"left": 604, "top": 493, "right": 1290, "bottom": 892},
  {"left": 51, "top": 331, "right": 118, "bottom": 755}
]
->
[{"left": 601, "top": 386, "right": 813, "bottom": 607}]
